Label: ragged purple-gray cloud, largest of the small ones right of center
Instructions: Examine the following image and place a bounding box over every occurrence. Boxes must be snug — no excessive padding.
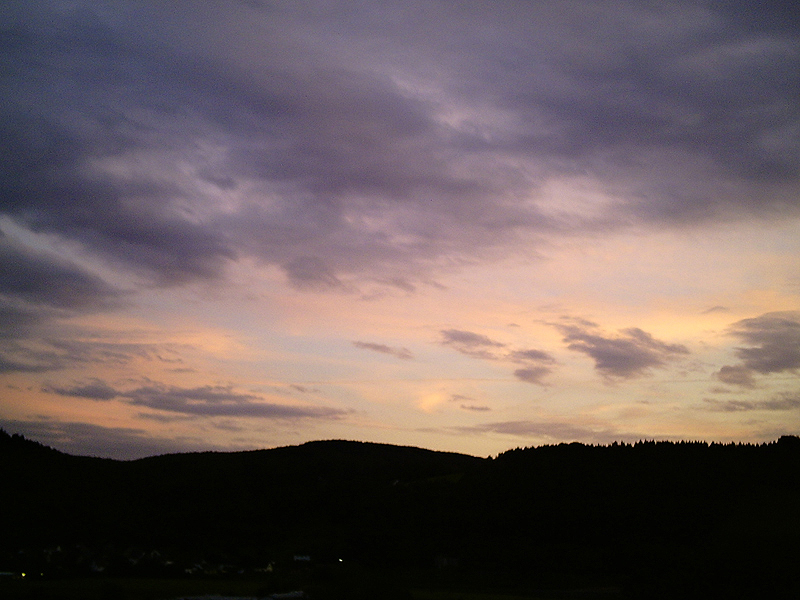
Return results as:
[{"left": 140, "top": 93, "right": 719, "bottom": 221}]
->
[{"left": 556, "top": 321, "right": 689, "bottom": 379}]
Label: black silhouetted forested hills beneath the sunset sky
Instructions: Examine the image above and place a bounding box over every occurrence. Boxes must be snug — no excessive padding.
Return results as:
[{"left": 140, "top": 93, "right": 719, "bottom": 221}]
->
[{"left": 0, "top": 431, "right": 800, "bottom": 597}]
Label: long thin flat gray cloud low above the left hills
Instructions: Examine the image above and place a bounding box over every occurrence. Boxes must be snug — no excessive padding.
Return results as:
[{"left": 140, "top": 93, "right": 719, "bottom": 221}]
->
[{"left": 43, "top": 379, "right": 348, "bottom": 420}]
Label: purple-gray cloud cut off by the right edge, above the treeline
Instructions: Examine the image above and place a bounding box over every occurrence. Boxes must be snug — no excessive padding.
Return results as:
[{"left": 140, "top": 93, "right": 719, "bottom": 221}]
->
[{"left": 716, "top": 311, "right": 800, "bottom": 388}]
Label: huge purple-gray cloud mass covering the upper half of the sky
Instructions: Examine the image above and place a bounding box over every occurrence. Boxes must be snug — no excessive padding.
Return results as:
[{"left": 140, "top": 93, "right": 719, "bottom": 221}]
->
[{"left": 0, "top": 0, "right": 800, "bottom": 302}]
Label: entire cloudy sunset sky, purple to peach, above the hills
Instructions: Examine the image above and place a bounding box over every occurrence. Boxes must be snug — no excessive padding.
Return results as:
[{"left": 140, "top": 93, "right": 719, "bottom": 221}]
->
[{"left": 0, "top": 0, "right": 800, "bottom": 459}]
